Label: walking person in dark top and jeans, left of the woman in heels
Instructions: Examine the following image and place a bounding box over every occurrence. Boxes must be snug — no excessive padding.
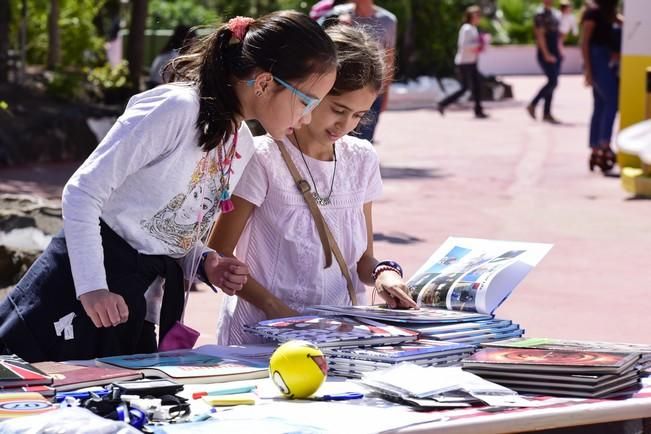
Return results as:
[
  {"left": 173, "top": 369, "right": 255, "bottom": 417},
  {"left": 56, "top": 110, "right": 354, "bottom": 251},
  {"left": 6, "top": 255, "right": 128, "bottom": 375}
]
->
[{"left": 527, "top": 0, "right": 562, "bottom": 124}]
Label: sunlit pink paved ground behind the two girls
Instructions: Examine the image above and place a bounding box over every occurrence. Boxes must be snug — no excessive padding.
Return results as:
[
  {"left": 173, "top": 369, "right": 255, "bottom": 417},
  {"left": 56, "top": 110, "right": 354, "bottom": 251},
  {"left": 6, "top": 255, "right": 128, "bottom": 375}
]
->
[{"left": 0, "top": 76, "right": 651, "bottom": 344}]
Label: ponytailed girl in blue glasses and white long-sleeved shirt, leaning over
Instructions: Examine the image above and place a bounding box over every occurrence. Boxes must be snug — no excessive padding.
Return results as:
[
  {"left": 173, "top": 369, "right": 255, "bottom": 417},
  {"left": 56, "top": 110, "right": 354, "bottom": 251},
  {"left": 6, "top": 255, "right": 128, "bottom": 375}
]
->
[{"left": 0, "top": 12, "right": 336, "bottom": 362}]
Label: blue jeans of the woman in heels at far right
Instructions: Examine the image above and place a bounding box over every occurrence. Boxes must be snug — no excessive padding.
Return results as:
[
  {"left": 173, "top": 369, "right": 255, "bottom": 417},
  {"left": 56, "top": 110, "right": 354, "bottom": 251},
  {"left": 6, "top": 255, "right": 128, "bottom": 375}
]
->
[{"left": 590, "top": 45, "right": 619, "bottom": 148}]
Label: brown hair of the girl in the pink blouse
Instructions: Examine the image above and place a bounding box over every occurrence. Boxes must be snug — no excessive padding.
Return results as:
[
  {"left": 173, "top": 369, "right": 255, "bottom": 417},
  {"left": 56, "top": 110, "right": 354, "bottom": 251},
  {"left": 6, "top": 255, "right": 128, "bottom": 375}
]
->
[{"left": 326, "top": 24, "right": 385, "bottom": 96}]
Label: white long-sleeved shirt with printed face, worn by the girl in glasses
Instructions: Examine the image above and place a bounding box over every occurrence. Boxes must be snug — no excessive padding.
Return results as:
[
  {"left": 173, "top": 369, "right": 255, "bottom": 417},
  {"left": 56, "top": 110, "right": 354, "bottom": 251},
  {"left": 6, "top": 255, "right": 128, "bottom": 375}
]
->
[{"left": 62, "top": 83, "right": 253, "bottom": 297}]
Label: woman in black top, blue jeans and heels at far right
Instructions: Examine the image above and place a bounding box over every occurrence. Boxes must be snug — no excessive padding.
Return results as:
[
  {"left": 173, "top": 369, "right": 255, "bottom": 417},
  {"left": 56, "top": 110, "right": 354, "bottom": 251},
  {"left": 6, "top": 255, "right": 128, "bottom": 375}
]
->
[{"left": 581, "top": 0, "right": 622, "bottom": 173}]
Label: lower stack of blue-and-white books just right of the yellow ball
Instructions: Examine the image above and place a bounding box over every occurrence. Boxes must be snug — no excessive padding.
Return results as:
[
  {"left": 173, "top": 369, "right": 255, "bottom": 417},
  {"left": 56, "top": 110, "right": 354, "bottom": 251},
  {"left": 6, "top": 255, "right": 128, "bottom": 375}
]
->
[{"left": 325, "top": 339, "right": 475, "bottom": 378}]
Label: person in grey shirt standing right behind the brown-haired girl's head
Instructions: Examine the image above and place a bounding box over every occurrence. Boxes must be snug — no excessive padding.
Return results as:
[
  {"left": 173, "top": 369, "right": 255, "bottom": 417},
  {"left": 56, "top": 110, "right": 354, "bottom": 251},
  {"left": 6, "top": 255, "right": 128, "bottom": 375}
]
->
[{"left": 324, "top": 0, "right": 398, "bottom": 142}]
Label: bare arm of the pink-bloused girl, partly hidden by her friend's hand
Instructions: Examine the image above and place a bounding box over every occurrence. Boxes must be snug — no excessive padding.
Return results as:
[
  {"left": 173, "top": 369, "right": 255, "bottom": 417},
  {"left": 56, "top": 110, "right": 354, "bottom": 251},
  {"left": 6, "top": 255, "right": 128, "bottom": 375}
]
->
[{"left": 208, "top": 196, "right": 298, "bottom": 319}]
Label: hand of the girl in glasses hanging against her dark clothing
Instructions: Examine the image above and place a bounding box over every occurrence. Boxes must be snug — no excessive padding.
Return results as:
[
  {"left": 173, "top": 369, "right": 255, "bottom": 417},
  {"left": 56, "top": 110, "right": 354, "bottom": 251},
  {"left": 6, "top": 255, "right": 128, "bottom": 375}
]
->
[{"left": 79, "top": 289, "right": 129, "bottom": 328}]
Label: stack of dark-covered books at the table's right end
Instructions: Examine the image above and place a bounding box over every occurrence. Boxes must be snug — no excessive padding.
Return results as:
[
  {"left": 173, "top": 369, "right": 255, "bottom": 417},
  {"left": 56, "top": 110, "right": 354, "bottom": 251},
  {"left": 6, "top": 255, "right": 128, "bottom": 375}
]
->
[{"left": 462, "top": 347, "right": 640, "bottom": 398}]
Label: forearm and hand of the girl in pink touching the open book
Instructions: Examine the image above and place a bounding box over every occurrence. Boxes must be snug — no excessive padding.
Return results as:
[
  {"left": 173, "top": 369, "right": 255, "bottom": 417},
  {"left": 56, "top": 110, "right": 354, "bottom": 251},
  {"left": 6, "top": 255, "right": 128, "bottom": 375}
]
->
[{"left": 357, "top": 202, "right": 417, "bottom": 308}]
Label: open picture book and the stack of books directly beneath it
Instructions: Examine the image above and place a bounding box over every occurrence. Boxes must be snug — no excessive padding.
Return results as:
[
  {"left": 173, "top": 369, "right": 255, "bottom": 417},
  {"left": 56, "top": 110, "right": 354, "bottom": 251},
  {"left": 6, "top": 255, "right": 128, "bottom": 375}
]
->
[{"left": 313, "top": 237, "right": 551, "bottom": 344}]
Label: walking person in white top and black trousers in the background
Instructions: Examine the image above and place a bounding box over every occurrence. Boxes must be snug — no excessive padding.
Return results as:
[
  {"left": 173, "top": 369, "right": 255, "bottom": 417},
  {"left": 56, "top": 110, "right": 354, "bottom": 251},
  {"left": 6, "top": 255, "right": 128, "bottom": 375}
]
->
[{"left": 438, "top": 6, "right": 488, "bottom": 119}]
